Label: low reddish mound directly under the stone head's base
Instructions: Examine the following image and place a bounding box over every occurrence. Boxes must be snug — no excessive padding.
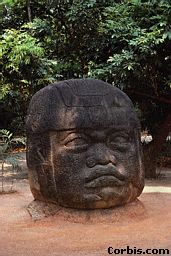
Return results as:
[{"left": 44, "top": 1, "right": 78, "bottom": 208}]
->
[{"left": 27, "top": 199, "right": 147, "bottom": 225}]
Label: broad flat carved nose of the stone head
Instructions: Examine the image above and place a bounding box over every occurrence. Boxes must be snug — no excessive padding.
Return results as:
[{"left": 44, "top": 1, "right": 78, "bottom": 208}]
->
[{"left": 86, "top": 143, "right": 116, "bottom": 168}]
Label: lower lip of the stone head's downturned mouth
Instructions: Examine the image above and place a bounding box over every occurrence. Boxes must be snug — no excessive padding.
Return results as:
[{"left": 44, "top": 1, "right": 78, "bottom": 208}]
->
[{"left": 85, "top": 174, "right": 125, "bottom": 188}]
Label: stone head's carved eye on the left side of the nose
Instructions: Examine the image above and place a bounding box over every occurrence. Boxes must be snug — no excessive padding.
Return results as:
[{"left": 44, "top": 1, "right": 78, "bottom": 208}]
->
[{"left": 64, "top": 133, "right": 88, "bottom": 148}]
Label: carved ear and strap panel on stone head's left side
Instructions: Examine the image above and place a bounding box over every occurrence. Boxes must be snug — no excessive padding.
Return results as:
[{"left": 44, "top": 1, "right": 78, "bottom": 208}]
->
[{"left": 26, "top": 132, "right": 57, "bottom": 201}]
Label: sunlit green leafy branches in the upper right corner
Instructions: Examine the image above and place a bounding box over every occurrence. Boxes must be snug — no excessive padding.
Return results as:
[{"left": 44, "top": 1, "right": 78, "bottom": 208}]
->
[{"left": 89, "top": 1, "right": 171, "bottom": 84}]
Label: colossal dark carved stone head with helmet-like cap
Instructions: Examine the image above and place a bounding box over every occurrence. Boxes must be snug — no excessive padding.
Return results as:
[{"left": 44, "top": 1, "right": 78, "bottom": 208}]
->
[{"left": 26, "top": 79, "right": 144, "bottom": 209}]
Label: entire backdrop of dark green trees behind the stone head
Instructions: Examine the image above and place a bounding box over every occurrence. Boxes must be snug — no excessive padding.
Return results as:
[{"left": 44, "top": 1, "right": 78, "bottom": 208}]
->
[{"left": 0, "top": 0, "right": 171, "bottom": 177}]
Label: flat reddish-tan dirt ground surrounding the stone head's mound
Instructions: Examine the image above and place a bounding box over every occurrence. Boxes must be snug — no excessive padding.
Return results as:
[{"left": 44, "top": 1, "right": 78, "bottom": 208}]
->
[{"left": 0, "top": 163, "right": 171, "bottom": 256}]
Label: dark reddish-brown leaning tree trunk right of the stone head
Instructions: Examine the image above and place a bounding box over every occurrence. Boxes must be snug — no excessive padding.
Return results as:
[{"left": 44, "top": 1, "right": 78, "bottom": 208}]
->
[{"left": 143, "top": 109, "right": 171, "bottom": 178}]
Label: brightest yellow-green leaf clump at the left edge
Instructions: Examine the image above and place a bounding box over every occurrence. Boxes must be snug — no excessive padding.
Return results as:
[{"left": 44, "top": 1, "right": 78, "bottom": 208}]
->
[{"left": 0, "top": 29, "right": 44, "bottom": 70}]
